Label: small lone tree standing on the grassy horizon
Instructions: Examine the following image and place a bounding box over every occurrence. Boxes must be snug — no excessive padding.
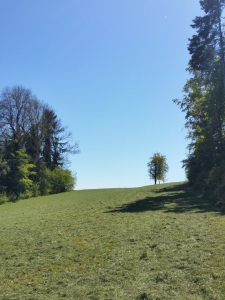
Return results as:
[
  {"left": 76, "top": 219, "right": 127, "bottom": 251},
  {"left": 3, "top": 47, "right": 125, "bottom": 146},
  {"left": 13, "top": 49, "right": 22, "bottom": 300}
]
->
[{"left": 148, "top": 152, "right": 169, "bottom": 184}]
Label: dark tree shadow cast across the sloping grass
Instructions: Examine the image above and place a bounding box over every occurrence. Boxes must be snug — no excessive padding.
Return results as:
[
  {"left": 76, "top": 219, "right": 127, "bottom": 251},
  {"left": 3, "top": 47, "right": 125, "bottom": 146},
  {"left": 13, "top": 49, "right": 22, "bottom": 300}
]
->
[{"left": 106, "top": 183, "right": 219, "bottom": 213}]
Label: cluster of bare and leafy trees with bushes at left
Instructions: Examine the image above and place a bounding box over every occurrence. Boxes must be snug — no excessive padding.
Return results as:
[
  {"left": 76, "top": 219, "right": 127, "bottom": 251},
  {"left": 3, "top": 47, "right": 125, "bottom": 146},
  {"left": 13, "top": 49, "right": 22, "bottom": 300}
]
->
[{"left": 0, "top": 86, "right": 79, "bottom": 201}]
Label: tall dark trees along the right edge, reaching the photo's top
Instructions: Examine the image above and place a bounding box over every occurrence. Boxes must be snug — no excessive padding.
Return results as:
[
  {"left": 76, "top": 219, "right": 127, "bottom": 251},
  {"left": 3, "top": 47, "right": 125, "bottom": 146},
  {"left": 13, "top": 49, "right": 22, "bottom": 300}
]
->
[{"left": 174, "top": 0, "right": 225, "bottom": 209}]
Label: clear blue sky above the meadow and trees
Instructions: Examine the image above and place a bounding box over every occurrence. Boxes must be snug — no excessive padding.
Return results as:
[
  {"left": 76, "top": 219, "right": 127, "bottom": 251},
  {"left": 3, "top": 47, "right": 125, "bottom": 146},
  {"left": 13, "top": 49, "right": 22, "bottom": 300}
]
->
[{"left": 0, "top": 0, "right": 201, "bottom": 190}]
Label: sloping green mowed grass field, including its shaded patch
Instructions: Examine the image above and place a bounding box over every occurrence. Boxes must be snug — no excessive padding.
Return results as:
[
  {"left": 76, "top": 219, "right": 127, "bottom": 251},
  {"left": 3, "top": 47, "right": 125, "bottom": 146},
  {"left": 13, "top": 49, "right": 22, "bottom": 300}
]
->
[{"left": 0, "top": 183, "right": 225, "bottom": 300}]
